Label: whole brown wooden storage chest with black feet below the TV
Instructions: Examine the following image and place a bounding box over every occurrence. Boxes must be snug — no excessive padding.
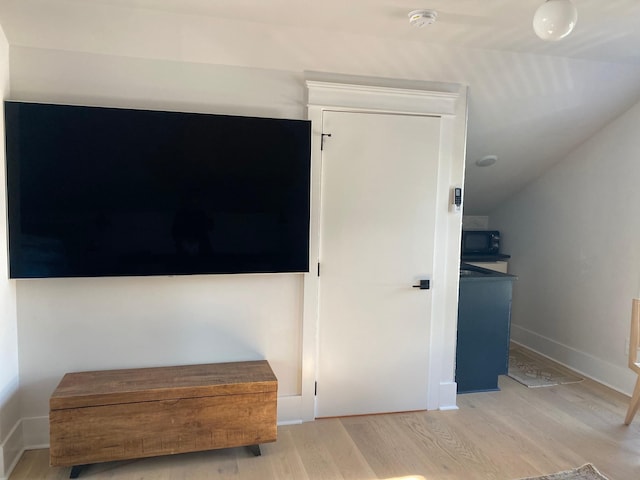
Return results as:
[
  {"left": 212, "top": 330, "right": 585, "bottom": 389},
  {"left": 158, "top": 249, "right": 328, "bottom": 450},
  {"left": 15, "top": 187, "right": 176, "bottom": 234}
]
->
[{"left": 49, "top": 360, "right": 278, "bottom": 476}]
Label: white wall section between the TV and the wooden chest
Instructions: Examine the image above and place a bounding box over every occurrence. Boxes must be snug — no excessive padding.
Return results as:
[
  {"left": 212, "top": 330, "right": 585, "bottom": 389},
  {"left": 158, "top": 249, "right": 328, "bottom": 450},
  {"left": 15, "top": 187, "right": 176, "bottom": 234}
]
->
[{"left": 17, "top": 275, "right": 302, "bottom": 404}]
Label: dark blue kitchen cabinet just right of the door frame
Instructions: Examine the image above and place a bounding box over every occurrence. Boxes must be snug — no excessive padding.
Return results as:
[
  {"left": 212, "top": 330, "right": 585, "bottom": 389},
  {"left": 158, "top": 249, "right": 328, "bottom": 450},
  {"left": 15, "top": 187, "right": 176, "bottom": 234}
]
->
[{"left": 456, "top": 267, "right": 516, "bottom": 393}]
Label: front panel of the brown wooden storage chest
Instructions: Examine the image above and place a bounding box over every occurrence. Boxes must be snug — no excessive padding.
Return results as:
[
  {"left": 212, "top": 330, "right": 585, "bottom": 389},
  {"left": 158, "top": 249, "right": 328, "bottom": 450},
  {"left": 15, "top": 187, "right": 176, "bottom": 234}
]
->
[{"left": 50, "top": 391, "right": 277, "bottom": 466}]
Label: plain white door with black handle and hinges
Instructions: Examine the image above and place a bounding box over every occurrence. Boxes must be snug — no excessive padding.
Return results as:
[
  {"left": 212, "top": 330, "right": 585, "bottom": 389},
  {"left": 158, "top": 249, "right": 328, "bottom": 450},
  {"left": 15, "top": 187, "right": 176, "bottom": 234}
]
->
[{"left": 316, "top": 112, "right": 440, "bottom": 417}]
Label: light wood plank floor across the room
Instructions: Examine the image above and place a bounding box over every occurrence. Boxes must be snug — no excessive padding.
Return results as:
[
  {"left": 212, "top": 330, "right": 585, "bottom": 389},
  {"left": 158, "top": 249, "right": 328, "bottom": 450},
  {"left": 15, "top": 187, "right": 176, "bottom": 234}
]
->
[{"left": 10, "top": 360, "right": 640, "bottom": 480}]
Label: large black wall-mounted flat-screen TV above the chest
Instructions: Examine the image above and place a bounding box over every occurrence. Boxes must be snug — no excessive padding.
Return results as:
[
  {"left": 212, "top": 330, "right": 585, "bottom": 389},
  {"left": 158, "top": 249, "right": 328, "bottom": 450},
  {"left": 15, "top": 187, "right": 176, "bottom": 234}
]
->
[{"left": 5, "top": 101, "right": 311, "bottom": 278}]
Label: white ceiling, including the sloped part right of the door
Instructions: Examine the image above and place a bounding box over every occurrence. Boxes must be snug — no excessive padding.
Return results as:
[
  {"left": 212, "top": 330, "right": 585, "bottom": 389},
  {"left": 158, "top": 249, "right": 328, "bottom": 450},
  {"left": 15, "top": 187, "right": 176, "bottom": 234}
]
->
[{"left": 0, "top": 0, "right": 640, "bottom": 214}]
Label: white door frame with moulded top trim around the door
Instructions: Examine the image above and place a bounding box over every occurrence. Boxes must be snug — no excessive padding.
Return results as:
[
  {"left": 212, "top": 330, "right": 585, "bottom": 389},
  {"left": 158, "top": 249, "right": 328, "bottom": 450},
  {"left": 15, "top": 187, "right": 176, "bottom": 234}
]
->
[{"left": 299, "top": 78, "right": 467, "bottom": 421}]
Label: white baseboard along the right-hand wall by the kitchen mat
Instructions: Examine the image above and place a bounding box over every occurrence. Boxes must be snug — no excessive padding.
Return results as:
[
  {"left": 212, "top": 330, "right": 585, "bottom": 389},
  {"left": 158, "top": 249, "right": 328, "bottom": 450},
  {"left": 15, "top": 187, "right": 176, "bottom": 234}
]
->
[{"left": 511, "top": 324, "right": 637, "bottom": 396}]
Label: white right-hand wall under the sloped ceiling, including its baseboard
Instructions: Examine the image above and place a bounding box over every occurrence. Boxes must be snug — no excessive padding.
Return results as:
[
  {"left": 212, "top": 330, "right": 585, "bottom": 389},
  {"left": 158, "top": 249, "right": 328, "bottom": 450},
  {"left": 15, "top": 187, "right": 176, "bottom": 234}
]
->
[{"left": 490, "top": 99, "right": 640, "bottom": 393}]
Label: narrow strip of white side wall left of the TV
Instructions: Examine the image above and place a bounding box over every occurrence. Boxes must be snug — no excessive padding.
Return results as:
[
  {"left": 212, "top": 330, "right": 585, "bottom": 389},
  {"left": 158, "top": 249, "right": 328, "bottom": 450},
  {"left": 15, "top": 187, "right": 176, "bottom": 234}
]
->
[{"left": 0, "top": 28, "right": 22, "bottom": 478}]
